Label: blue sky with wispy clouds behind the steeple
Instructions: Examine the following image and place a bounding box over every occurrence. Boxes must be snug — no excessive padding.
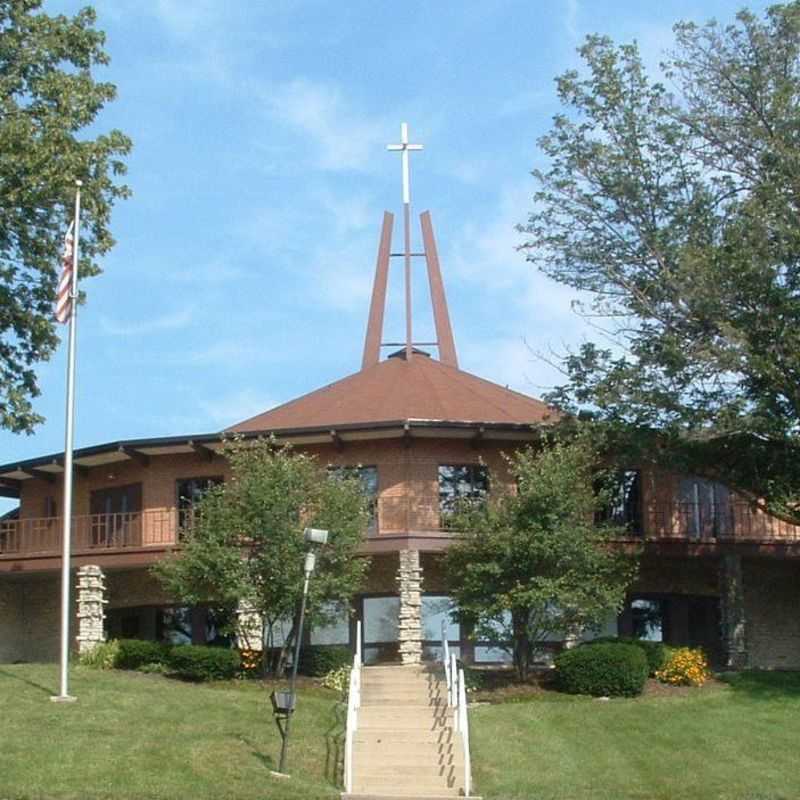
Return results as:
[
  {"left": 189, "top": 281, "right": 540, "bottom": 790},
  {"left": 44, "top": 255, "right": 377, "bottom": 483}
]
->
[{"left": 0, "top": 0, "right": 766, "bottom": 500}]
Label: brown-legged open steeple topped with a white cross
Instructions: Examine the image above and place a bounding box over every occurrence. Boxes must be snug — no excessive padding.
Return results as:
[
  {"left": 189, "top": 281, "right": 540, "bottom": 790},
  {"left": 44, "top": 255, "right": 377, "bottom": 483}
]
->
[{"left": 361, "top": 122, "right": 458, "bottom": 369}]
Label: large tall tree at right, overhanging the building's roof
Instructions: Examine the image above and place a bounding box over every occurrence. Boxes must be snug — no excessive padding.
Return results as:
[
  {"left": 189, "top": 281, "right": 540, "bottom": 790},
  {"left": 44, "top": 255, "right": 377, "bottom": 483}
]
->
[{"left": 522, "top": 2, "right": 800, "bottom": 517}]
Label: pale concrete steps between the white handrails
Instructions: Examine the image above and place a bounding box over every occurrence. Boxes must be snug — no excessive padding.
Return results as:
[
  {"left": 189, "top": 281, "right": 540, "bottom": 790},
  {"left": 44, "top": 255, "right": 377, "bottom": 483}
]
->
[{"left": 342, "top": 666, "right": 476, "bottom": 800}]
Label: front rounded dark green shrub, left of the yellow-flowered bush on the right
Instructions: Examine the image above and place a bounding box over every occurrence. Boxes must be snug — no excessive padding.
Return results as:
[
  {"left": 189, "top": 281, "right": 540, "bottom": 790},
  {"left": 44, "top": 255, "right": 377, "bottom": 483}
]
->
[{"left": 555, "top": 642, "right": 647, "bottom": 697}]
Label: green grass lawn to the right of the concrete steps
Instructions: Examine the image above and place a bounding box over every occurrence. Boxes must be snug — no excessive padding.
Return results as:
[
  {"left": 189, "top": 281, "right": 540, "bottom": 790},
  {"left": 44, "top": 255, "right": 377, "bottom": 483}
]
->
[{"left": 470, "top": 673, "right": 800, "bottom": 800}]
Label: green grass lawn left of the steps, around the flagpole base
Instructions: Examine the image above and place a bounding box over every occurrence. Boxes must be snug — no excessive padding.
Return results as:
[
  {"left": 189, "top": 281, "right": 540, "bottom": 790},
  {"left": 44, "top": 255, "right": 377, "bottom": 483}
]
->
[{"left": 0, "top": 664, "right": 343, "bottom": 800}]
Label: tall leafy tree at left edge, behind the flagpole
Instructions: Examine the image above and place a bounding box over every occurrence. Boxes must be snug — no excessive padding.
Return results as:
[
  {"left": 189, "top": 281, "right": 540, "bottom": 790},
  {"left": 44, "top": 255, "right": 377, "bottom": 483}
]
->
[{"left": 0, "top": 0, "right": 131, "bottom": 433}]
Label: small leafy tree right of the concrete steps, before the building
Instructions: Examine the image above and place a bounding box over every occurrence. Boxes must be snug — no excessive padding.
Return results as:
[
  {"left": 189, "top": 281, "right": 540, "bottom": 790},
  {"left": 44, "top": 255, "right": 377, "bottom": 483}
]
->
[{"left": 445, "top": 432, "right": 636, "bottom": 680}]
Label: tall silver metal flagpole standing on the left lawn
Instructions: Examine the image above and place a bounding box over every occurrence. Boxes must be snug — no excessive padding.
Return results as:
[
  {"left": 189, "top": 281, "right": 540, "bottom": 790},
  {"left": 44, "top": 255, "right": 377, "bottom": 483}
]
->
[{"left": 50, "top": 181, "right": 83, "bottom": 703}]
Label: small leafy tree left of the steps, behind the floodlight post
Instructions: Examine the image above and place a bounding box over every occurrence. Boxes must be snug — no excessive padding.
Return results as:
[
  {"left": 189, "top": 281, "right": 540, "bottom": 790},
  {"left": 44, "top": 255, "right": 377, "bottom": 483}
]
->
[{"left": 153, "top": 439, "right": 369, "bottom": 673}]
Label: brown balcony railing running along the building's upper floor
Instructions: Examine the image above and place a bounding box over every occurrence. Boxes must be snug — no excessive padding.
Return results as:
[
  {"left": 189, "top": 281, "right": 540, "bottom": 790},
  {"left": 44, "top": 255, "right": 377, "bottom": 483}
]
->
[{"left": 0, "top": 497, "right": 800, "bottom": 558}]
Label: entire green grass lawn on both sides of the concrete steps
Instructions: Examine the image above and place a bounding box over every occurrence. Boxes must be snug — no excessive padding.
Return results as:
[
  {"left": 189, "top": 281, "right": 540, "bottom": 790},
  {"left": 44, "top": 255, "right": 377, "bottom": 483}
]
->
[{"left": 6, "top": 665, "right": 800, "bottom": 800}]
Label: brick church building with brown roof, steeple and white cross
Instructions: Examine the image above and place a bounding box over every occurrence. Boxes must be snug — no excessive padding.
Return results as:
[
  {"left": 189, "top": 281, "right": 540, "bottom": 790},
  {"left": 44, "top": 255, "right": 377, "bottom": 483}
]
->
[{"left": 0, "top": 130, "right": 800, "bottom": 668}]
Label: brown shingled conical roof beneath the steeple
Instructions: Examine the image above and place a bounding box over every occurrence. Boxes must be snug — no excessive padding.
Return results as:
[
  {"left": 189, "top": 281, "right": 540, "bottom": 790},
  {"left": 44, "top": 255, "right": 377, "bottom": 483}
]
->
[{"left": 228, "top": 354, "right": 555, "bottom": 433}]
